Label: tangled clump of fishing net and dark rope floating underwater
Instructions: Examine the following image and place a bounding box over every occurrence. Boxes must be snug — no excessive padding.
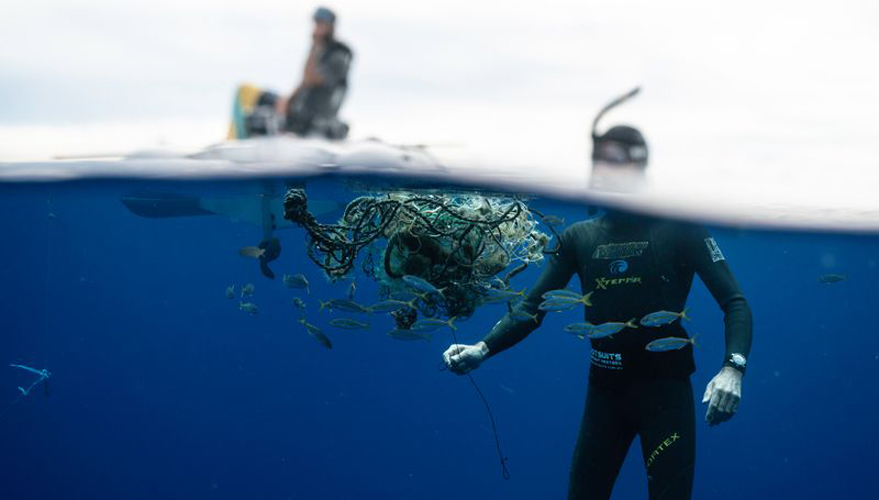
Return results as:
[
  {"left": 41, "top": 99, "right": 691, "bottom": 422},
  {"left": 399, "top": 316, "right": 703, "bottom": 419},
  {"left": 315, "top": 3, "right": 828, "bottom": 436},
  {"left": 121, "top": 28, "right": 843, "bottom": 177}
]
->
[{"left": 284, "top": 189, "right": 550, "bottom": 317}]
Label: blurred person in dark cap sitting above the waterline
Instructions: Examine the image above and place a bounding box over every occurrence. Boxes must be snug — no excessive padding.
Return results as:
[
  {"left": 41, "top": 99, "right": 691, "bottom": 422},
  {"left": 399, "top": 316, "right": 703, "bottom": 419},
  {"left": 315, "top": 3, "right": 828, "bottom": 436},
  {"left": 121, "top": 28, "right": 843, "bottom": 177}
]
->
[{"left": 276, "top": 7, "right": 354, "bottom": 139}]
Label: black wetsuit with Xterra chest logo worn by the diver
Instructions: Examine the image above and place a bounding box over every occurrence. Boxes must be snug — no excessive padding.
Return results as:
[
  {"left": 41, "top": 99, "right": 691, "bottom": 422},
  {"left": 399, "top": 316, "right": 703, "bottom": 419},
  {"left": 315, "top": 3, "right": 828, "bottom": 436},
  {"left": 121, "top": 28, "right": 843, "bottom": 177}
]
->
[{"left": 485, "top": 215, "right": 751, "bottom": 500}]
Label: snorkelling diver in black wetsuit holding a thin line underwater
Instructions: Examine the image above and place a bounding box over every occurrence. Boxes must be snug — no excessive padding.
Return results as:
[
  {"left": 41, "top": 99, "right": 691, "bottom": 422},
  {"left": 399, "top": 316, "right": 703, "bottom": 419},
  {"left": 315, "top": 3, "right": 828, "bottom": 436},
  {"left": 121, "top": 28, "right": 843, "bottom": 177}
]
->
[{"left": 443, "top": 122, "right": 752, "bottom": 500}]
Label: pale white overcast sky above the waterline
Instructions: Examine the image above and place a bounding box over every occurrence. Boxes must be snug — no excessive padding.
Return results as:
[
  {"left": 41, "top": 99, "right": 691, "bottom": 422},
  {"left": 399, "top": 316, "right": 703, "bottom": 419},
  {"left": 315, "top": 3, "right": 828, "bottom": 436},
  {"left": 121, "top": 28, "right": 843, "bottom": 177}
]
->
[{"left": 0, "top": 0, "right": 879, "bottom": 215}]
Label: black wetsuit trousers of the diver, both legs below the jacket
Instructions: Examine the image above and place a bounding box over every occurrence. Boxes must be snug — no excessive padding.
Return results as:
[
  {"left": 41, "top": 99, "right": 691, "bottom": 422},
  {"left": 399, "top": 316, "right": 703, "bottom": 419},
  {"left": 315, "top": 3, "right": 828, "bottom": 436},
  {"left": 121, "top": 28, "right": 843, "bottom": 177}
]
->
[{"left": 568, "top": 377, "right": 696, "bottom": 500}]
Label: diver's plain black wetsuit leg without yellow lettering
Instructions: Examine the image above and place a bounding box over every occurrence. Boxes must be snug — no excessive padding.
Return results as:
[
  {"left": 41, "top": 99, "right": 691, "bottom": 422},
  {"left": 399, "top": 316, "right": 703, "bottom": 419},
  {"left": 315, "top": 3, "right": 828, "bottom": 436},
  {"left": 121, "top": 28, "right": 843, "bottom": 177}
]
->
[{"left": 568, "top": 384, "right": 637, "bottom": 500}]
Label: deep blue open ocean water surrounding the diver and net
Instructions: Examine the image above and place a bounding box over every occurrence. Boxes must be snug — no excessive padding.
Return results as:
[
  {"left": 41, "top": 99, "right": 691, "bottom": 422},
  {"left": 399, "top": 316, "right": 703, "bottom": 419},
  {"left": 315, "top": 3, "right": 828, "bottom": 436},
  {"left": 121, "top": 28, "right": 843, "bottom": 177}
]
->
[{"left": 0, "top": 179, "right": 879, "bottom": 500}]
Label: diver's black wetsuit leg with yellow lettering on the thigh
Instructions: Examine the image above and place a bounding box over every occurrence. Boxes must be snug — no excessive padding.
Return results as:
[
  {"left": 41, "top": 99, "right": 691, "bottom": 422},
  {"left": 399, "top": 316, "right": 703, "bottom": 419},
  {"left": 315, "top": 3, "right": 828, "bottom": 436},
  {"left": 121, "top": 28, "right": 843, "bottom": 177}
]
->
[{"left": 638, "top": 377, "right": 696, "bottom": 500}]
